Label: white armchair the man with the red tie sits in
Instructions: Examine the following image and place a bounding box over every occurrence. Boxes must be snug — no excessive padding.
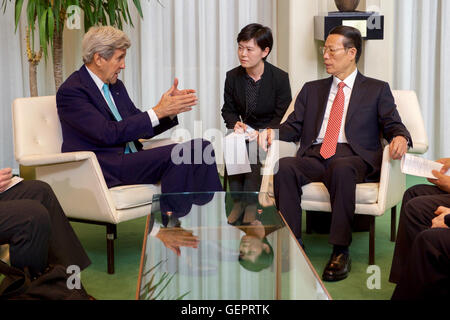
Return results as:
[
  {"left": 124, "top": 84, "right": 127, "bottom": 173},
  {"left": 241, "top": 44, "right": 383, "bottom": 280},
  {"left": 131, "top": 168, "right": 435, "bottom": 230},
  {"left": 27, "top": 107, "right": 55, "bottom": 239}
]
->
[{"left": 259, "top": 91, "right": 428, "bottom": 265}]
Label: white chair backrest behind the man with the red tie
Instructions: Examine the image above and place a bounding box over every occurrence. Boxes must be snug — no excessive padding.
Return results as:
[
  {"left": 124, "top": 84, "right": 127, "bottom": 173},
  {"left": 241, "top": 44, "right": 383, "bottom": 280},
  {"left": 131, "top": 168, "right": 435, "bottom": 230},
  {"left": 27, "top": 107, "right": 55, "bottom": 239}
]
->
[{"left": 281, "top": 90, "right": 428, "bottom": 154}]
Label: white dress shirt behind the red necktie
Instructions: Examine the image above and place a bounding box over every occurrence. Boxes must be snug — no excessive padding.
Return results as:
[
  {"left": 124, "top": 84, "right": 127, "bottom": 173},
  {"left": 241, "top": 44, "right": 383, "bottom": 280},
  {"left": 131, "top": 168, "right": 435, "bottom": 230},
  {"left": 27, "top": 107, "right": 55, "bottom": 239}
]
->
[{"left": 314, "top": 69, "right": 358, "bottom": 144}]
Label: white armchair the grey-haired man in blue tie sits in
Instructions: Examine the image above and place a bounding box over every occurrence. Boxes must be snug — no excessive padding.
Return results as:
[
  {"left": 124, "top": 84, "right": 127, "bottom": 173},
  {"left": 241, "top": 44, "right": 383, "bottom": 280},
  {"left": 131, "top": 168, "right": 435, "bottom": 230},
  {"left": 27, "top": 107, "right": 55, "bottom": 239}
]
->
[{"left": 13, "top": 96, "right": 178, "bottom": 274}]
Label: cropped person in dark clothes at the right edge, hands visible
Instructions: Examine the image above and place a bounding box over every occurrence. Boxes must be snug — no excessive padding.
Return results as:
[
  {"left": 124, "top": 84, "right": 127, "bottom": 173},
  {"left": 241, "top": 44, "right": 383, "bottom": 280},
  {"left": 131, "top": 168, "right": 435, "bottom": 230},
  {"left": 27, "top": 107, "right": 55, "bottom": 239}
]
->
[{"left": 389, "top": 158, "right": 450, "bottom": 300}]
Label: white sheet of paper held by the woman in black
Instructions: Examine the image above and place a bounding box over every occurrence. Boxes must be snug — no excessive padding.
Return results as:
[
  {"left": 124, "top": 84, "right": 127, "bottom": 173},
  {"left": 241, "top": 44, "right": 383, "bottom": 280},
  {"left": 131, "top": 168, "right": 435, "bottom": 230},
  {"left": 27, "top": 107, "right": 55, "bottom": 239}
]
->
[{"left": 224, "top": 133, "right": 252, "bottom": 176}]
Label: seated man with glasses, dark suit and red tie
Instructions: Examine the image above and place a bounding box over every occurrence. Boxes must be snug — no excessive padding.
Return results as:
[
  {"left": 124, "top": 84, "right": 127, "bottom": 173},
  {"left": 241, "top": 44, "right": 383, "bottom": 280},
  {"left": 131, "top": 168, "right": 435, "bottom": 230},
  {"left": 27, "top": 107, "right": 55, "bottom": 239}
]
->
[{"left": 260, "top": 26, "right": 411, "bottom": 281}]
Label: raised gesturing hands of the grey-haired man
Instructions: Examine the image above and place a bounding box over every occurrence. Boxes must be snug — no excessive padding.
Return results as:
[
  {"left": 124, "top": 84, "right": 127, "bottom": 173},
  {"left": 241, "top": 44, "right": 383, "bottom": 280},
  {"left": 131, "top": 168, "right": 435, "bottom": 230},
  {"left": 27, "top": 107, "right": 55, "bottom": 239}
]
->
[{"left": 153, "top": 78, "right": 198, "bottom": 119}]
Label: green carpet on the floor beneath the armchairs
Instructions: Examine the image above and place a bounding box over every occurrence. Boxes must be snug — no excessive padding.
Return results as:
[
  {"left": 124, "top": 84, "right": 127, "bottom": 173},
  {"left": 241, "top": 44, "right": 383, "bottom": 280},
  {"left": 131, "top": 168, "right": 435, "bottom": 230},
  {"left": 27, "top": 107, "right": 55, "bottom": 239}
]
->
[{"left": 72, "top": 177, "right": 426, "bottom": 300}]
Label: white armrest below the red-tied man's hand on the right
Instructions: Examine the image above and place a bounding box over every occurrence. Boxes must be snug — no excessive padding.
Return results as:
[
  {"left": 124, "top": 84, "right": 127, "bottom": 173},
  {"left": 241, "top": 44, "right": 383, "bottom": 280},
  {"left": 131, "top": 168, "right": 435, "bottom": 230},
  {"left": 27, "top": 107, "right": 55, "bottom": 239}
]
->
[{"left": 378, "top": 146, "right": 406, "bottom": 213}]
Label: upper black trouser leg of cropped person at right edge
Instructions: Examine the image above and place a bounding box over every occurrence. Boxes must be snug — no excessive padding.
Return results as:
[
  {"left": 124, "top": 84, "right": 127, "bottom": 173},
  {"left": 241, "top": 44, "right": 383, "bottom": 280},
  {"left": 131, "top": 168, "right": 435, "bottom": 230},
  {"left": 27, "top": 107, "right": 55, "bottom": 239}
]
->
[{"left": 389, "top": 185, "right": 450, "bottom": 283}]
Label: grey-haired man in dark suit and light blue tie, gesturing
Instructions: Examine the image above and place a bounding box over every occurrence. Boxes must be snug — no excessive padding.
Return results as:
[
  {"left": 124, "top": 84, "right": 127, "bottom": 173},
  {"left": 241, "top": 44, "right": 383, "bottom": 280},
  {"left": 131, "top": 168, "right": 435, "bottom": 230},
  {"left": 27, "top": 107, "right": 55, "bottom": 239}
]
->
[{"left": 56, "top": 27, "right": 222, "bottom": 193}]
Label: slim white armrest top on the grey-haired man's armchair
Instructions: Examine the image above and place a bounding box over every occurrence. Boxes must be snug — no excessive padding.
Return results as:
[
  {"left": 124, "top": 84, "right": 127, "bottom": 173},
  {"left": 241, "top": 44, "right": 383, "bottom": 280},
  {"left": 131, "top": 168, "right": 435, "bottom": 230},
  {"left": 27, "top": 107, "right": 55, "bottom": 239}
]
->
[{"left": 17, "top": 151, "right": 95, "bottom": 167}]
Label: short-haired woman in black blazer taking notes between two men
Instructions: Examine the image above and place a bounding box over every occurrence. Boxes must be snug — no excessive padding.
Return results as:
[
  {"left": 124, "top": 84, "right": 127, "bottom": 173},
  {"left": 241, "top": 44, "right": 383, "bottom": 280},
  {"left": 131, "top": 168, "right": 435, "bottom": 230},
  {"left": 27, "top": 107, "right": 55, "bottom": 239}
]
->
[{"left": 222, "top": 24, "right": 292, "bottom": 223}]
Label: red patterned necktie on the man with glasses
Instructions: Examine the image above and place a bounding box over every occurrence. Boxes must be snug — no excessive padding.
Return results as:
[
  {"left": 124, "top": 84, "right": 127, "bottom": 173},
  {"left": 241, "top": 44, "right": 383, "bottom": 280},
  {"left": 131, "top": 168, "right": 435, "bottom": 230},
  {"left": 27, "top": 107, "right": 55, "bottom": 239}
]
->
[{"left": 320, "top": 82, "right": 345, "bottom": 159}]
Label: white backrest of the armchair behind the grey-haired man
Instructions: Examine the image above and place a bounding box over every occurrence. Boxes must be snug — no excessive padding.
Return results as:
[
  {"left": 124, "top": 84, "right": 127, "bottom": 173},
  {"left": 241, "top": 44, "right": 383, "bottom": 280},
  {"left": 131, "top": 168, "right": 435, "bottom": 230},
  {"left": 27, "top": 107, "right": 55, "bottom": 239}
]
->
[{"left": 12, "top": 96, "right": 62, "bottom": 161}]
